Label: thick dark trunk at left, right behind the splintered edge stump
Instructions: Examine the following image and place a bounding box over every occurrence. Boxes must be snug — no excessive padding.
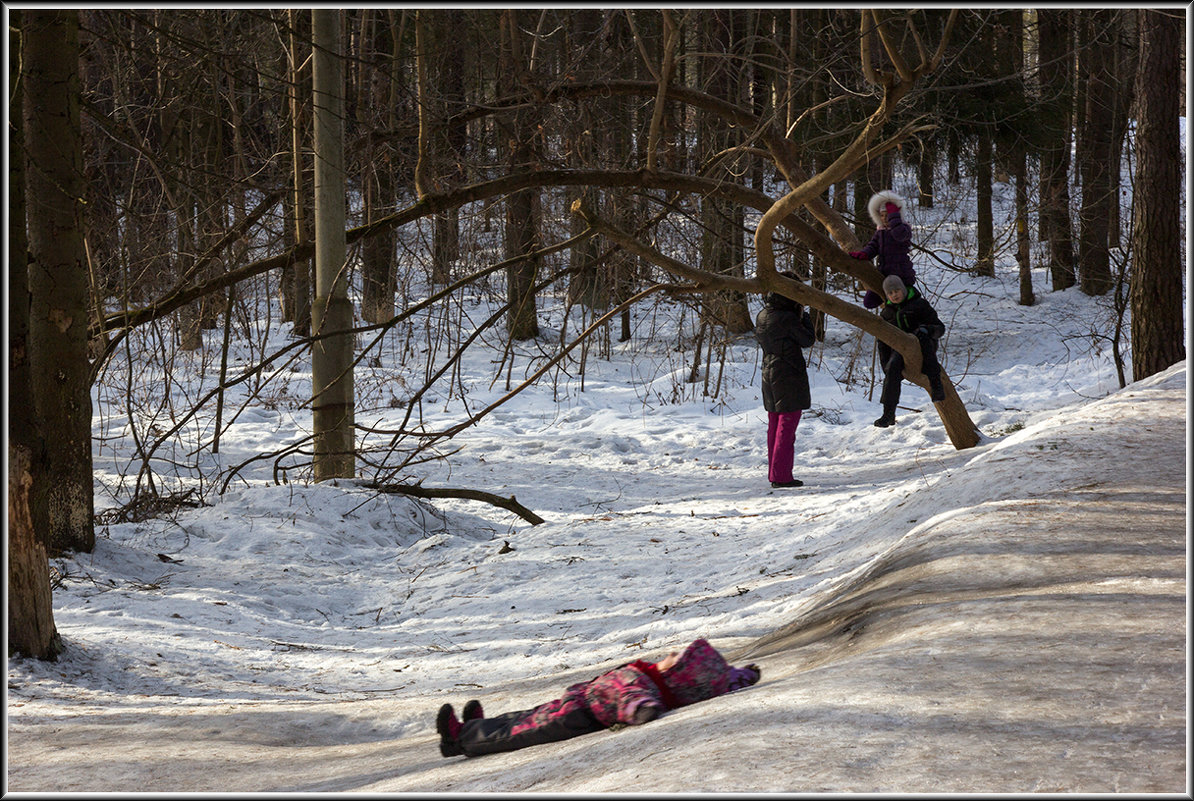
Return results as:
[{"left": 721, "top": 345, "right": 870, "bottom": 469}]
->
[{"left": 23, "top": 10, "right": 96, "bottom": 553}]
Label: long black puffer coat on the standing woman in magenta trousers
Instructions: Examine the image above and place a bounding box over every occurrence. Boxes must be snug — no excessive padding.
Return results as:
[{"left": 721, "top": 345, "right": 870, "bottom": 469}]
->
[{"left": 755, "top": 292, "right": 816, "bottom": 413}]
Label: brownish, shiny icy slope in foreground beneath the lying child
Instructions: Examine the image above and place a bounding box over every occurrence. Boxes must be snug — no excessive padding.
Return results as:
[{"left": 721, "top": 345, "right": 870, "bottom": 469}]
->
[{"left": 8, "top": 369, "right": 1189, "bottom": 794}]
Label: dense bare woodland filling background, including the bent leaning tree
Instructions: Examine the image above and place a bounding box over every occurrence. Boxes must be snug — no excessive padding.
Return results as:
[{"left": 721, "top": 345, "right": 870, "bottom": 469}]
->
[{"left": 6, "top": 6, "right": 1186, "bottom": 659}]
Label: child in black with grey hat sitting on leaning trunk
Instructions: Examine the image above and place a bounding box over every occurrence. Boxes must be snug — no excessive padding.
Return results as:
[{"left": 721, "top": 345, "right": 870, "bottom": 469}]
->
[{"left": 875, "top": 276, "right": 946, "bottom": 429}]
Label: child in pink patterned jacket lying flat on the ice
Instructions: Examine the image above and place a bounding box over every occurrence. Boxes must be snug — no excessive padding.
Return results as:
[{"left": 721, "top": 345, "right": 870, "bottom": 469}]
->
[{"left": 436, "top": 639, "right": 761, "bottom": 757}]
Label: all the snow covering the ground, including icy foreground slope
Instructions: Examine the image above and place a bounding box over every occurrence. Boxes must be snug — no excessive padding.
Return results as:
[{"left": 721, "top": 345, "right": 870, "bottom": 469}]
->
[{"left": 7, "top": 186, "right": 1189, "bottom": 794}]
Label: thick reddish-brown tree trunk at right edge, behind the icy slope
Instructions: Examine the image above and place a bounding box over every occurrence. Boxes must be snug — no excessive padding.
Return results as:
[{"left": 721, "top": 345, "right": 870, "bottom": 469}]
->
[{"left": 1131, "top": 10, "right": 1186, "bottom": 381}]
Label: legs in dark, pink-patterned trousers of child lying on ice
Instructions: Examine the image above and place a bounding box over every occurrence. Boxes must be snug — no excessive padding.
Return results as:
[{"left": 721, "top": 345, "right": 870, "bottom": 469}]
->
[{"left": 457, "top": 700, "right": 605, "bottom": 757}]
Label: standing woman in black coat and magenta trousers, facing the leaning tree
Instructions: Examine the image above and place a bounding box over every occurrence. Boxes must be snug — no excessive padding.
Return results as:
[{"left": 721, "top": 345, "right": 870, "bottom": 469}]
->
[{"left": 755, "top": 281, "right": 816, "bottom": 488}]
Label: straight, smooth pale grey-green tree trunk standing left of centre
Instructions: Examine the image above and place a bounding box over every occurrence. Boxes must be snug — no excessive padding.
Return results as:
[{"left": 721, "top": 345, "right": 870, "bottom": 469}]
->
[{"left": 312, "top": 8, "right": 356, "bottom": 481}]
